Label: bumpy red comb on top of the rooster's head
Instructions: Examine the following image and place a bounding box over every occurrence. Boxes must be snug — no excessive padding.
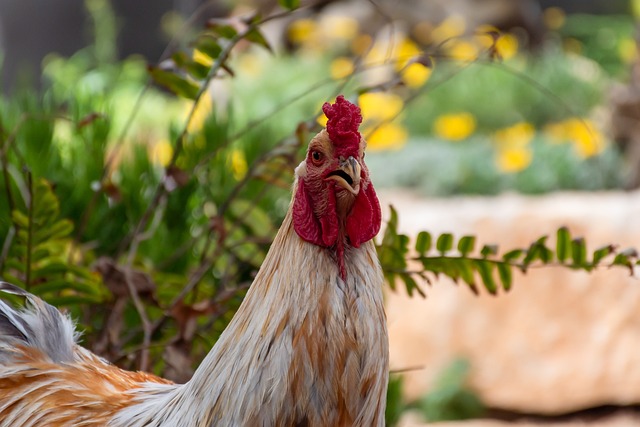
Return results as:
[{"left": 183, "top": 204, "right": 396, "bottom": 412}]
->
[{"left": 322, "top": 95, "right": 362, "bottom": 157}]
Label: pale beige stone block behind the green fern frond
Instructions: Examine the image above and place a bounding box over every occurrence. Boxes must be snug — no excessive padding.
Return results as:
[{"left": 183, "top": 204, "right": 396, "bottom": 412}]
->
[{"left": 381, "top": 191, "right": 640, "bottom": 418}]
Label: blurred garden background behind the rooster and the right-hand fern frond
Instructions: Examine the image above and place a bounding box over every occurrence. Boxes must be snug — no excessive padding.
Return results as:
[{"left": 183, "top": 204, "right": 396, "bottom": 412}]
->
[{"left": 0, "top": 0, "right": 640, "bottom": 427}]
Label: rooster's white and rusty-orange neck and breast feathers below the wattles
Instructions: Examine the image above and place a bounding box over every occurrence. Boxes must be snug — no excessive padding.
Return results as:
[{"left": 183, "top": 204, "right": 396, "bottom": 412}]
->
[{"left": 111, "top": 212, "right": 388, "bottom": 427}]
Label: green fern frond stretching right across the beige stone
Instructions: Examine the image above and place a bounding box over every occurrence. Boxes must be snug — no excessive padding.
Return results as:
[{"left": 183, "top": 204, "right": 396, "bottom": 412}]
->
[{"left": 377, "top": 207, "right": 640, "bottom": 296}]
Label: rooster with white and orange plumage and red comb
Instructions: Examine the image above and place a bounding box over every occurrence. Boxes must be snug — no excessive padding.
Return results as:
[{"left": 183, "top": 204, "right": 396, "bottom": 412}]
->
[{"left": 0, "top": 96, "right": 388, "bottom": 427}]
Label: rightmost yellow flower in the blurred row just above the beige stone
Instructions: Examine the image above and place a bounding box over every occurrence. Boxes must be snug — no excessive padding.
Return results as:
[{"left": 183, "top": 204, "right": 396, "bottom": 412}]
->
[{"left": 544, "top": 118, "right": 606, "bottom": 158}]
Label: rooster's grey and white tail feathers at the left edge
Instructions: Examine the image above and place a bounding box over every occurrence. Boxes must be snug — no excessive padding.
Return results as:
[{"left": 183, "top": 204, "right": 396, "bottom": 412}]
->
[{"left": 0, "top": 281, "right": 79, "bottom": 364}]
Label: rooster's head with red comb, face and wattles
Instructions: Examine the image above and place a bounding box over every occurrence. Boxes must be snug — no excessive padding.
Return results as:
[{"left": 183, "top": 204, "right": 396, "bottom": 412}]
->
[{"left": 293, "top": 95, "right": 381, "bottom": 256}]
